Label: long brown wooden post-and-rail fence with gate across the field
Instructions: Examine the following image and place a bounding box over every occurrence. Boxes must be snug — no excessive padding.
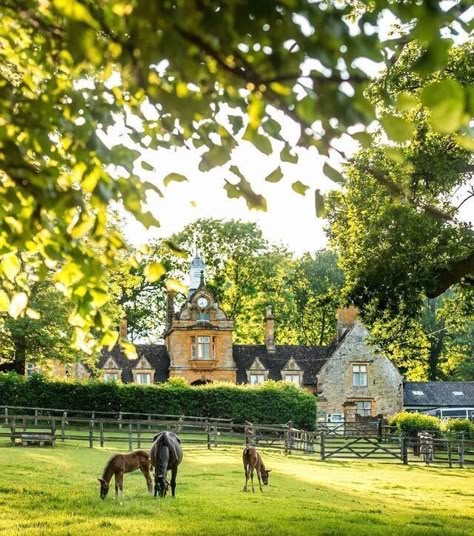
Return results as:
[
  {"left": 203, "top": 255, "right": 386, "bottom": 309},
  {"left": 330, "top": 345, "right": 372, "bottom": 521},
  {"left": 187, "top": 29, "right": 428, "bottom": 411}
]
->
[{"left": 0, "top": 406, "right": 474, "bottom": 467}]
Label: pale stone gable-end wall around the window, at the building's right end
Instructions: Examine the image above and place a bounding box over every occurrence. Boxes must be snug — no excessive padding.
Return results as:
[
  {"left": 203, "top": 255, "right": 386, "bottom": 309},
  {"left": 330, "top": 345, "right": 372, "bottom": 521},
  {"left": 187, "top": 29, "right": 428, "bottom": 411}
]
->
[{"left": 317, "top": 323, "right": 402, "bottom": 420}]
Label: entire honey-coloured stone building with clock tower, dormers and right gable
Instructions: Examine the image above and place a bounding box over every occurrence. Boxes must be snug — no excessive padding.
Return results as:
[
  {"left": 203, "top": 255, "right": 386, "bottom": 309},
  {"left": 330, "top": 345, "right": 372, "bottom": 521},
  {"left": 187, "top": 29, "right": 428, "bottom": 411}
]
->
[{"left": 95, "top": 255, "right": 402, "bottom": 420}]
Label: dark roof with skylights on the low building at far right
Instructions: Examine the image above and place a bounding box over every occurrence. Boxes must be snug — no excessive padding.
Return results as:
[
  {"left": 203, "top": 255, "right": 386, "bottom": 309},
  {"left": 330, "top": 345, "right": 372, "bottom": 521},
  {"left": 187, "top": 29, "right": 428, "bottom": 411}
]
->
[{"left": 403, "top": 382, "right": 474, "bottom": 408}]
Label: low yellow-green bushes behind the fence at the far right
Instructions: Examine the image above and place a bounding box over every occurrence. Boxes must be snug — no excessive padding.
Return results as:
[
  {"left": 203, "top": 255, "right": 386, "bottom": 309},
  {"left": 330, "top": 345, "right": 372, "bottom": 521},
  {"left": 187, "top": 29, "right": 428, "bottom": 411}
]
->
[{"left": 390, "top": 412, "right": 474, "bottom": 439}]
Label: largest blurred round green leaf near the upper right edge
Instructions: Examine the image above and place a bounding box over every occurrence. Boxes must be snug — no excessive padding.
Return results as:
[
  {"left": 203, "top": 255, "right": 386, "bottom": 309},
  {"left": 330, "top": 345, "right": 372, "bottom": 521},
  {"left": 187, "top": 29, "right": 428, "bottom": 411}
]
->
[{"left": 421, "top": 80, "right": 465, "bottom": 133}]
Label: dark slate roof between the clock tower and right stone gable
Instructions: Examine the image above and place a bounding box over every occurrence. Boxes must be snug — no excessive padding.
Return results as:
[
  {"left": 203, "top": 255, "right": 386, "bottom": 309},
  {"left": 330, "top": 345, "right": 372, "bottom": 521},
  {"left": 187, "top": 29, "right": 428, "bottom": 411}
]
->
[{"left": 233, "top": 344, "right": 334, "bottom": 385}]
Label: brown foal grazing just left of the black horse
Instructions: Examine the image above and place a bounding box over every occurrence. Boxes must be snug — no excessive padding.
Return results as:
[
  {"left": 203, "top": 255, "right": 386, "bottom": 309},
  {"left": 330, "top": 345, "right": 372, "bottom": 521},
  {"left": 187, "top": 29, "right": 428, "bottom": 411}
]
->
[{"left": 97, "top": 450, "right": 153, "bottom": 499}]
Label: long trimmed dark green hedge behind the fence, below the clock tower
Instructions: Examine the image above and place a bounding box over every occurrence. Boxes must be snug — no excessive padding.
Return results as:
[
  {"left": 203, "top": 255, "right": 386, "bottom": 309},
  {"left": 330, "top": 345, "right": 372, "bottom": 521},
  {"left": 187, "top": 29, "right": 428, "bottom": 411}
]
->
[{"left": 0, "top": 373, "right": 316, "bottom": 430}]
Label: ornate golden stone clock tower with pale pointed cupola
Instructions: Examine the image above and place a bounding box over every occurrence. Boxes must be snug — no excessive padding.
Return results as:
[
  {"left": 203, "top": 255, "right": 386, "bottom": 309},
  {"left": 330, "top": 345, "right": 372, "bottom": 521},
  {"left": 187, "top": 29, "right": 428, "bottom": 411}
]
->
[{"left": 165, "top": 253, "right": 236, "bottom": 384}]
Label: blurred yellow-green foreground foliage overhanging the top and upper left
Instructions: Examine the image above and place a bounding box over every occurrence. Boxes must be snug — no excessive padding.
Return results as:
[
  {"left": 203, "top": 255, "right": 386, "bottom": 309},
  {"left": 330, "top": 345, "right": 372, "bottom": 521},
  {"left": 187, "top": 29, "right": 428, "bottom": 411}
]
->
[{"left": 0, "top": 0, "right": 470, "bottom": 351}]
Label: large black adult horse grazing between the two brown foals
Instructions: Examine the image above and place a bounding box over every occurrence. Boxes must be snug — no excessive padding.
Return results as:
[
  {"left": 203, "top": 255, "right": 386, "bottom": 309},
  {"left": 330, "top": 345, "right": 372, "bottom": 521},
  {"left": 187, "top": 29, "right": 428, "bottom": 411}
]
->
[{"left": 150, "top": 432, "right": 183, "bottom": 497}]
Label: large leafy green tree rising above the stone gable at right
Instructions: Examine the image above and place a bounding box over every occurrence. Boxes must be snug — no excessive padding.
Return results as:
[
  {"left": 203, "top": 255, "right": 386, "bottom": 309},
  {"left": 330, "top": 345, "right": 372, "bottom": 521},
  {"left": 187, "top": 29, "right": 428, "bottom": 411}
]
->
[{"left": 329, "top": 43, "right": 474, "bottom": 321}]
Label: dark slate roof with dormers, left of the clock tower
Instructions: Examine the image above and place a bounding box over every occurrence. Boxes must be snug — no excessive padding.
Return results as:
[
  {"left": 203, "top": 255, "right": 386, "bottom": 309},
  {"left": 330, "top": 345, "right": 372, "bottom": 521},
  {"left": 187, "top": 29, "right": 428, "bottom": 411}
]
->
[{"left": 98, "top": 344, "right": 170, "bottom": 383}]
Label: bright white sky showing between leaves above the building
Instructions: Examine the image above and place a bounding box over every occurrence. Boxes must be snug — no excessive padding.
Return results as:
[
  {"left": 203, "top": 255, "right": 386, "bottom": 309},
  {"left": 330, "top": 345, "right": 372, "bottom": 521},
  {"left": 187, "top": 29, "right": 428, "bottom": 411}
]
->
[{"left": 108, "top": 2, "right": 472, "bottom": 254}]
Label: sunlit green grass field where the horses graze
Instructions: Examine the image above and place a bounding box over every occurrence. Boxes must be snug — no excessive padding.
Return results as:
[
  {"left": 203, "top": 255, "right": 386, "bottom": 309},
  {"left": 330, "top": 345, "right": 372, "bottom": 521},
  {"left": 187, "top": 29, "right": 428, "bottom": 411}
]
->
[{"left": 0, "top": 446, "right": 474, "bottom": 536}]
